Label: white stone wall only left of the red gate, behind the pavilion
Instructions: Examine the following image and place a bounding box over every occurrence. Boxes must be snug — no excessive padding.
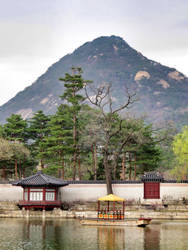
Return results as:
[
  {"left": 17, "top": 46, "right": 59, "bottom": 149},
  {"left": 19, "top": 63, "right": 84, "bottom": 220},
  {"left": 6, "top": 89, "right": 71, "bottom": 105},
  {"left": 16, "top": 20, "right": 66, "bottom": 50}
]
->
[{"left": 0, "top": 183, "right": 143, "bottom": 202}]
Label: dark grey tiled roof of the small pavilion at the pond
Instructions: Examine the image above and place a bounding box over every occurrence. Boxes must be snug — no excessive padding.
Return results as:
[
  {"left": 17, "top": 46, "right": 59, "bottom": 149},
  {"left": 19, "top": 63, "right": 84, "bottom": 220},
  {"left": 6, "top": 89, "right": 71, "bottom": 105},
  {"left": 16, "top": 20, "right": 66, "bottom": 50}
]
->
[{"left": 12, "top": 171, "right": 68, "bottom": 187}]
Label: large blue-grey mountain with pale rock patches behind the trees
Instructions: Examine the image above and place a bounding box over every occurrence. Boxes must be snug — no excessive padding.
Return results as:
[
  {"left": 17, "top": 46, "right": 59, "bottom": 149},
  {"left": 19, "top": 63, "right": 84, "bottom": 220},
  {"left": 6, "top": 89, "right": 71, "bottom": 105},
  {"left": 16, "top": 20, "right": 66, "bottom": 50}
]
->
[{"left": 0, "top": 36, "right": 188, "bottom": 126}]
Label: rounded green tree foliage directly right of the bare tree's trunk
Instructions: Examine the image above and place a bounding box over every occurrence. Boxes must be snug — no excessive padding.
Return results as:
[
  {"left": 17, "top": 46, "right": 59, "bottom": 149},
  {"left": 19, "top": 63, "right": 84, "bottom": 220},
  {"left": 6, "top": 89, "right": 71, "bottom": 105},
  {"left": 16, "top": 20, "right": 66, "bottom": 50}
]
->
[{"left": 111, "top": 117, "right": 162, "bottom": 178}]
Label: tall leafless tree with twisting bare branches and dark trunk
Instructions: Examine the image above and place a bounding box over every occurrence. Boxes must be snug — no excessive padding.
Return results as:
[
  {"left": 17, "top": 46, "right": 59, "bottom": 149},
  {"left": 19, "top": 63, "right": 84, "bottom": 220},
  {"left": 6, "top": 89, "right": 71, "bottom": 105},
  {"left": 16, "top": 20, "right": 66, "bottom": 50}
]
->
[{"left": 85, "top": 84, "right": 136, "bottom": 194}]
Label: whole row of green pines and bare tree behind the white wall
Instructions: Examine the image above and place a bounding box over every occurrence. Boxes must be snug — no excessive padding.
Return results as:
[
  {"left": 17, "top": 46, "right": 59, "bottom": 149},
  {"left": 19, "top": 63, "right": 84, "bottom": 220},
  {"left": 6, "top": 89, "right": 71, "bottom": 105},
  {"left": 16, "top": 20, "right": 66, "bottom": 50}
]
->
[{"left": 0, "top": 68, "right": 186, "bottom": 193}]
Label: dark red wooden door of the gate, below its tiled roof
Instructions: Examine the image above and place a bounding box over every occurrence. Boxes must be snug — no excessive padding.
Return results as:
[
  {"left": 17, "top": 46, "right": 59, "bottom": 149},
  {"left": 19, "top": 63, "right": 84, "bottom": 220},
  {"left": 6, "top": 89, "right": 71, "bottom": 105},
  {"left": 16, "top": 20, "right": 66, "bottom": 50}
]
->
[{"left": 144, "top": 182, "right": 160, "bottom": 199}]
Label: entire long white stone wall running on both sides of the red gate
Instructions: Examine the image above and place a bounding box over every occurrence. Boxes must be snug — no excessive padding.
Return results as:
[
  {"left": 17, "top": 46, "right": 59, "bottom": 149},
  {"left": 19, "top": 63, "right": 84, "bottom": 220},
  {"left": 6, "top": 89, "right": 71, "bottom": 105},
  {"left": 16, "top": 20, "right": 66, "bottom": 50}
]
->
[{"left": 0, "top": 183, "right": 188, "bottom": 203}]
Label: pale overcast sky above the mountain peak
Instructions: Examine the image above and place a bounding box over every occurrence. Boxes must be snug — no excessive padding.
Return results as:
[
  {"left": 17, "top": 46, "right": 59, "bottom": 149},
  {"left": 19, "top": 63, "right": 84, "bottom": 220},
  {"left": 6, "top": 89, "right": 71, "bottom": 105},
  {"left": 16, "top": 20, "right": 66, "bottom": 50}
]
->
[{"left": 0, "top": 0, "right": 188, "bottom": 105}]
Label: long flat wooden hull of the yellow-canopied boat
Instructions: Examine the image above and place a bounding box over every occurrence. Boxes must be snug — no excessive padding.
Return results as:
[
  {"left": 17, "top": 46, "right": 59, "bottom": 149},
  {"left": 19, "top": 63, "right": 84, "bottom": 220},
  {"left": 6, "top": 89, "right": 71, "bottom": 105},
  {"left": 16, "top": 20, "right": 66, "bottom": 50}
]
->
[{"left": 80, "top": 218, "right": 151, "bottom": 227}]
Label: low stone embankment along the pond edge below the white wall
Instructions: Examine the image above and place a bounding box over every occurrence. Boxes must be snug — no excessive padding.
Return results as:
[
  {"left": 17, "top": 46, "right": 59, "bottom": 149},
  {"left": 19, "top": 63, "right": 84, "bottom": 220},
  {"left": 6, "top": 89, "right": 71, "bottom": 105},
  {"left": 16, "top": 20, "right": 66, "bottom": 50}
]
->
[{"left": 0, "top": 202, "right": 188, "bottom": 220}]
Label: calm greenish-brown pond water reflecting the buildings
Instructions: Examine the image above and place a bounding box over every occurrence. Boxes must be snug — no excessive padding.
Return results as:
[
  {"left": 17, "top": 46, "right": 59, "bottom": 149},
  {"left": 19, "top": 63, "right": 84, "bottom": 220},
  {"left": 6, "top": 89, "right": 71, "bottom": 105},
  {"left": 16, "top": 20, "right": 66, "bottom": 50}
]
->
[{"left": 0, "top": 218, "right": 188, "bottom": 250}]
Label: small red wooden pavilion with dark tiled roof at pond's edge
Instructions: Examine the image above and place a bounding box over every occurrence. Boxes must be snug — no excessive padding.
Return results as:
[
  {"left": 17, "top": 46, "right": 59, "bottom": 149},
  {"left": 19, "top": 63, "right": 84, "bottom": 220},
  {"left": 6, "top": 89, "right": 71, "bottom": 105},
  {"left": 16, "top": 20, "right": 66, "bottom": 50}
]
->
[{"left": 13, "top": 171, "right": 68, "bottom": 210}]
